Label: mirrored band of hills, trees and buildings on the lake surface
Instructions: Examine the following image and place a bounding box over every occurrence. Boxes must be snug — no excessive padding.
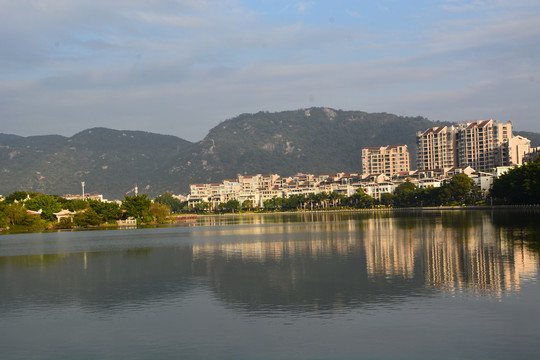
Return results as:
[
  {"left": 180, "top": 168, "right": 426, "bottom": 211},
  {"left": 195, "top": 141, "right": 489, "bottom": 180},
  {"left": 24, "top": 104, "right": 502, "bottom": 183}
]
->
[{"left": 0, "top": 211, "right": 539, "bottom": 314}]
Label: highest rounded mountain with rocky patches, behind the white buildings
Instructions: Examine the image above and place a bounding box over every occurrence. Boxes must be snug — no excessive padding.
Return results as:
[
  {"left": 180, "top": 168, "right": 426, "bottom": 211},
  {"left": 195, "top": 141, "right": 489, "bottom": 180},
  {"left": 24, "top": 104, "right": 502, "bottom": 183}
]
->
[{"left": 171, "top": 108, "right": 450, "bottom": 186}]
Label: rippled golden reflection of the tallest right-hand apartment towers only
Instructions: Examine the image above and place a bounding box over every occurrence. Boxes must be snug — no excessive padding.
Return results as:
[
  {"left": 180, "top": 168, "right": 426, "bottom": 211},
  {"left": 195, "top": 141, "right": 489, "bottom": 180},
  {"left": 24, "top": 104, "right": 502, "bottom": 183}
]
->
[{"left": 423, "top": 212, "right": 538, "bottom": 295}]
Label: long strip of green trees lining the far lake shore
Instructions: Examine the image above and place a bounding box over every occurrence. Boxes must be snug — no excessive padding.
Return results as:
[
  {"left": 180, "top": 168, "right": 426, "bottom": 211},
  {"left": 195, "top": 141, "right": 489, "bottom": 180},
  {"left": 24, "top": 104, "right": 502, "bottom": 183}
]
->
[{"left": 0, "top": 159, "right": 540, "bottom": 231}]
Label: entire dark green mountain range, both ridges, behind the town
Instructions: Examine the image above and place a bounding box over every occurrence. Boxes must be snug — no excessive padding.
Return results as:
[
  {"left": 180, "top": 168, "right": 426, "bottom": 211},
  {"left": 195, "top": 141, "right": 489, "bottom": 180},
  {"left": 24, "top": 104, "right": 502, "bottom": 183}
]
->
[{"left": 0, "top": 108, "right": 540, "bottom": 199}]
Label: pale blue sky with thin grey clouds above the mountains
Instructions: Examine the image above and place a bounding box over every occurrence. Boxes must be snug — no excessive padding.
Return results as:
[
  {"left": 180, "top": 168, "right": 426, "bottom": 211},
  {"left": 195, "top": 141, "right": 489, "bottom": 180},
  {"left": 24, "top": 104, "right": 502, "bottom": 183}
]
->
[{"left": 0, "top": 0, "right": 540, "bottom": 141}]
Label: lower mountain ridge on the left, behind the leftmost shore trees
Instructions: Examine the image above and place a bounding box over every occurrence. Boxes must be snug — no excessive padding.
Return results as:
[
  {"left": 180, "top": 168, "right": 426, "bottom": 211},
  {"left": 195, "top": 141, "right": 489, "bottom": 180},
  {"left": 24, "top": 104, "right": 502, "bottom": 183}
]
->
[{"left": 0, "top": 128, "right": 193, "bottom": 198}]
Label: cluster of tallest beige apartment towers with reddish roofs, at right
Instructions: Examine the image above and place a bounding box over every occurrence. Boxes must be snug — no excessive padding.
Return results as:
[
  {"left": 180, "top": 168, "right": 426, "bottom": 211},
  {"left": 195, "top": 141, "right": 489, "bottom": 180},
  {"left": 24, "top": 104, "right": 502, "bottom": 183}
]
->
[{"left": 416, "top": 120, "right": 530, "bottom": 171}]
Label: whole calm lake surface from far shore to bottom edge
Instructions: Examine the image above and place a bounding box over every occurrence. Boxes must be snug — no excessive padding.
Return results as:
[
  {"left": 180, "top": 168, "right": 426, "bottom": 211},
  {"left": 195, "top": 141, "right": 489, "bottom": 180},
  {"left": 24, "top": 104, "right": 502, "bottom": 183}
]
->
[{"left": 0, "top": 211, "right": 540, "bottom": 360}]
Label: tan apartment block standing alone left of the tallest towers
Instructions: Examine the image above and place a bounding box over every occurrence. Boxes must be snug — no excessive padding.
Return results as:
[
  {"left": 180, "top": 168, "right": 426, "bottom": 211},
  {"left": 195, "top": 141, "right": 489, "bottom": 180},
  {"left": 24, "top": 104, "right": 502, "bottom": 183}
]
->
[{"left": 362, "top": 145, "right": 410, "bottom": 176}]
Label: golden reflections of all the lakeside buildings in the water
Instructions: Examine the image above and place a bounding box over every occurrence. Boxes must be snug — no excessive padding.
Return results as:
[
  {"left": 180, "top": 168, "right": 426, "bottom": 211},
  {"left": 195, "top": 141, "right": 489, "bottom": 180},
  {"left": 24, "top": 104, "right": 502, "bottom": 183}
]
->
[{"left": 193, "top": 213, "right": 539, "bottom": 296}]
